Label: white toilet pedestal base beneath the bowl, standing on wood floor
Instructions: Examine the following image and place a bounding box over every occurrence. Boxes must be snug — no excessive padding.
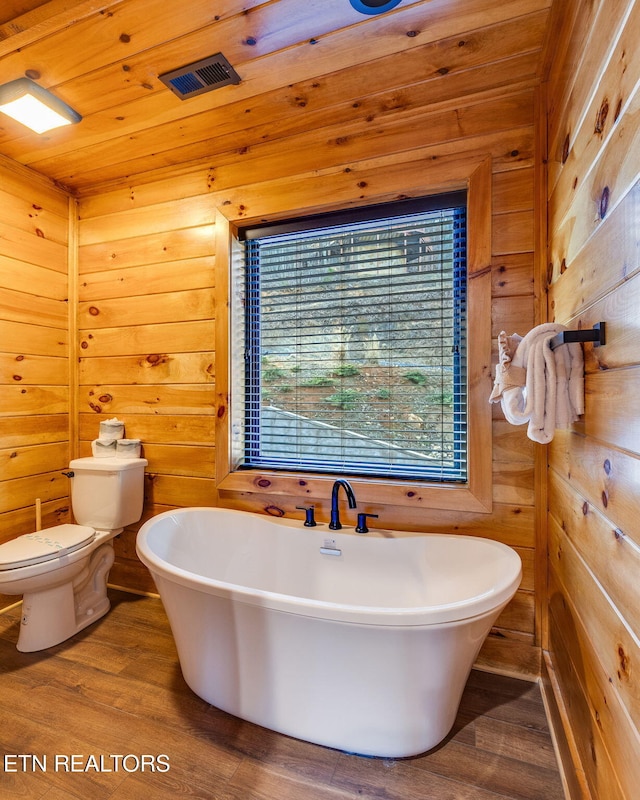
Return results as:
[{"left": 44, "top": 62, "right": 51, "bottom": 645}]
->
[{"left": 16, "top": 541, "right": 114, "bottom": 653}]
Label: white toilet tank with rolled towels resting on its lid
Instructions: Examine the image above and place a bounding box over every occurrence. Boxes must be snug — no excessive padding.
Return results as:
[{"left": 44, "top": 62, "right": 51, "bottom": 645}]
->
[{"left": 69, "top": 457, "right": 149, "bottom": 531}]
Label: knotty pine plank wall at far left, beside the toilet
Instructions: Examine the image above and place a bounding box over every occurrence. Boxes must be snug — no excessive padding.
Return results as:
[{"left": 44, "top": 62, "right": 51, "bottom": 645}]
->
[{"left": 0, "top": 158, "right": 69, "bottom": 605}]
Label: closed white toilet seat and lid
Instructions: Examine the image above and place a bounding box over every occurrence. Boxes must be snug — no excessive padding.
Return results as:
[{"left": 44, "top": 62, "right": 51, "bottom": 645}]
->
[{"left": 0, "top": 524, "right": 96, "bottom": 571}]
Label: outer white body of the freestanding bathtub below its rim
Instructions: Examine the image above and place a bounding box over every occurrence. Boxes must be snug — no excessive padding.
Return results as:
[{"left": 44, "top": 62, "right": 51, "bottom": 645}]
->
[{"left": 155, "top": 576, "right": 501, "bottom": 758}]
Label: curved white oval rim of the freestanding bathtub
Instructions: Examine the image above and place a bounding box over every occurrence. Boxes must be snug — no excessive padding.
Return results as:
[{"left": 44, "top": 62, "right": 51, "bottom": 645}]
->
[{"left": 136, "top": 506, "right": 522, "bottom": 628}]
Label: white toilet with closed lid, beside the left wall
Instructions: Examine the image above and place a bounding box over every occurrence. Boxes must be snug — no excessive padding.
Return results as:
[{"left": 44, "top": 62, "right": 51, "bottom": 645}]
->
[{"left": 0, "top": 457, "right": 148, "bottom": 653}]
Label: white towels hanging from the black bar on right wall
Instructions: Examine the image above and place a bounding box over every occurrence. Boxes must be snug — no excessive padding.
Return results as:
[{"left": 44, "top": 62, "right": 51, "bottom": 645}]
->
[{"left": 490, "top": 323, "right": 584, "bottom": 444}]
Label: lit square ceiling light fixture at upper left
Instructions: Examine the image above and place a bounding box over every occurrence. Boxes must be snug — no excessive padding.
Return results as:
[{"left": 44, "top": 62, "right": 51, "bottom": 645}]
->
[{"left": 0, "top": 78, "right": 82, "bottom": 133}]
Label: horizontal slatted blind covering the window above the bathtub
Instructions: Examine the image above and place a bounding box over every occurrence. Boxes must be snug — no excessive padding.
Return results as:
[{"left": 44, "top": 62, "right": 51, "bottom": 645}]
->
[{"left": 242, "top": 196, "right": 467, "bottom": 481}]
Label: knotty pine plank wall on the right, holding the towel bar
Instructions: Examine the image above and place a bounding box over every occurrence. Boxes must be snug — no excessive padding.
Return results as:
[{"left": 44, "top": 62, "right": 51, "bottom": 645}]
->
[{"left": 547, "top": 0, "right": 640, "bottom": 800}]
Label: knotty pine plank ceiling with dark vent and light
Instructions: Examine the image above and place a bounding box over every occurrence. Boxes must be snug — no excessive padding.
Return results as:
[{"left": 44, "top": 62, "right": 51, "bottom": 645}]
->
[{"left": 0, "top": 0, "right": 551, "bottom": 196}]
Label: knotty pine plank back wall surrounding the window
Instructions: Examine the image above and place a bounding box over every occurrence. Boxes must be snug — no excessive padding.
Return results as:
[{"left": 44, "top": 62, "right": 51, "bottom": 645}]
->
[{"left": 77, "top": 85, "right": 540, "bottom": 676}]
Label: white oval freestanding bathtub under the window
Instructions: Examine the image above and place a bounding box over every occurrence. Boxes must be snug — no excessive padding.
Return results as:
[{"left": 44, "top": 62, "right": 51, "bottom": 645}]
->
[{"left": 137, "top": 508, "right": 521, "bottom": 757}]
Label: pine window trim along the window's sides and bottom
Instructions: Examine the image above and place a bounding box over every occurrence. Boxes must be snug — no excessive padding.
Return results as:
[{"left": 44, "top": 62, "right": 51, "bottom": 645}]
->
[{"left": 216, "top": 159, "right": 492, "bottom": 513}]
